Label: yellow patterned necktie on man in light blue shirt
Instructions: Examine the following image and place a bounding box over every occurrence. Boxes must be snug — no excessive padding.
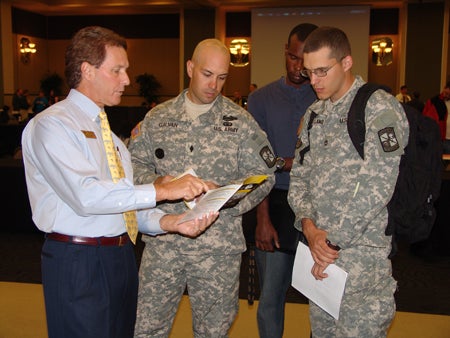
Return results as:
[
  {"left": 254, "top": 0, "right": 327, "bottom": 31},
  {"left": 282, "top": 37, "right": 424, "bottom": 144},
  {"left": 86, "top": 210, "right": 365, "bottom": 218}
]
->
[{"left": 99, "top": 111, "right": 138, "bottom": 244}]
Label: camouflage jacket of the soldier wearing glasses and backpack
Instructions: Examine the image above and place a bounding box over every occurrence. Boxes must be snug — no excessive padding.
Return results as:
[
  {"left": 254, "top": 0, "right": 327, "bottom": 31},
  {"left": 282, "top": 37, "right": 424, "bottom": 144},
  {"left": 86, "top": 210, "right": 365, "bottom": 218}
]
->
[{"left": 288, "top": 76, "right": 409, "bottom": 288}]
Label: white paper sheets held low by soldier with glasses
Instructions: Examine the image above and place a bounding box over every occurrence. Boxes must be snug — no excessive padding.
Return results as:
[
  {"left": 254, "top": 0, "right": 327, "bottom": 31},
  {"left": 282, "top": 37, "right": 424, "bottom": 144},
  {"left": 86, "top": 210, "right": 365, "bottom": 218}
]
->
[{"left": 292, "top": 242, "right": 347, "bottom": 319}]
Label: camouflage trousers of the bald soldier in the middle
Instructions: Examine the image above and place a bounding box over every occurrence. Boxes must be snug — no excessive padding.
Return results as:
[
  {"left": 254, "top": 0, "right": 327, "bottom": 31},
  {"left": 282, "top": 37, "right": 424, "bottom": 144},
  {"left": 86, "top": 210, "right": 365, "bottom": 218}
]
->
[{"left": 135, "top": 243, "right": 242, "bottom": 338}]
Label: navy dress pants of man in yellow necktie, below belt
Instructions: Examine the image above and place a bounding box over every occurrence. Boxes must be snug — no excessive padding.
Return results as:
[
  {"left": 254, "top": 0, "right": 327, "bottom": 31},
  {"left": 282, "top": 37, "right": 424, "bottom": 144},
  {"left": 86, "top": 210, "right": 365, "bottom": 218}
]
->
[{"left": 42, "top": 239, "right": 138, "bottom": 338}]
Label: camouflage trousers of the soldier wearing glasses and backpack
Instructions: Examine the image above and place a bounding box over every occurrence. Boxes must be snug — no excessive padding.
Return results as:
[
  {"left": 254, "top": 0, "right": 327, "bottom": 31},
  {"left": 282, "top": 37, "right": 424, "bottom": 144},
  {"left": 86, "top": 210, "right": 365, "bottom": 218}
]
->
[{"left": 309, "top": 276, "right": 396, "bottom": 338}]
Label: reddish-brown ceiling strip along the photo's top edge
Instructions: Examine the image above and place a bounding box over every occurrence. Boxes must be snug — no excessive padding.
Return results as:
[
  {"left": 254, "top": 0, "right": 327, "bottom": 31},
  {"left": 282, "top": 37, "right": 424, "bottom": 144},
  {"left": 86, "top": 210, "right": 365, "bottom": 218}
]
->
[{"left": 10, "top": 0, "right": 404, "bottom": 16}]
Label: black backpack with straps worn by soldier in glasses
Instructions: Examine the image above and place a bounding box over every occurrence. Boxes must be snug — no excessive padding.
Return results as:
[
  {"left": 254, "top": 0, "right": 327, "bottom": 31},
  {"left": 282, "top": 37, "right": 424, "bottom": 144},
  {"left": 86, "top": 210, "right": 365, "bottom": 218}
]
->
[{"left": 300, "top": 83, "right": 443, "bottom": 258}]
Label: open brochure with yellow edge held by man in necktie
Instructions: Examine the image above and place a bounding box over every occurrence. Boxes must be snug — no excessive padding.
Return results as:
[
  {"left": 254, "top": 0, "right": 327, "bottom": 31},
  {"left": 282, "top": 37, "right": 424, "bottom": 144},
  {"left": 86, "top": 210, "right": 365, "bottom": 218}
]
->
[{"left": 178, "top": 170, "right": 267, "bottom": 222}]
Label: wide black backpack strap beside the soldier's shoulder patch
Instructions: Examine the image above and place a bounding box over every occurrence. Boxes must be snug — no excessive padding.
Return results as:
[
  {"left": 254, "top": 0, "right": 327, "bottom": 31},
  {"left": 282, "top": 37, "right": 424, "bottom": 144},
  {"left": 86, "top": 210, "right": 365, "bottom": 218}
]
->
[{"left": 347, "top": 83, "right": 385, "bottom": 159}]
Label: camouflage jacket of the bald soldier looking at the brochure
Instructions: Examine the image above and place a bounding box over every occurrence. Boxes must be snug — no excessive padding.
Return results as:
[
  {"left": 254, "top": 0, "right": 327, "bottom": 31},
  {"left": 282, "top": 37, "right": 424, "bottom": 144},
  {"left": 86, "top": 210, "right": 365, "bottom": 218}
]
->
[{"left": 129, "top": 90, "right": 275, "bottom": 254}]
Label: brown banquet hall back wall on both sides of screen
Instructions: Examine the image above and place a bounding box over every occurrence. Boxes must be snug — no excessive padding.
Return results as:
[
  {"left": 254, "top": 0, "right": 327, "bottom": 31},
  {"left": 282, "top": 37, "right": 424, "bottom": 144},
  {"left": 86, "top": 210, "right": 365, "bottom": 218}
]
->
[{"left": 0, "top": 1, "right": 449, "bottom": 106}]
